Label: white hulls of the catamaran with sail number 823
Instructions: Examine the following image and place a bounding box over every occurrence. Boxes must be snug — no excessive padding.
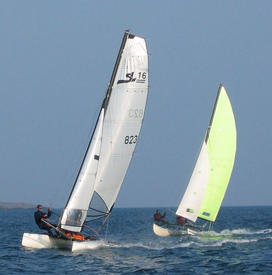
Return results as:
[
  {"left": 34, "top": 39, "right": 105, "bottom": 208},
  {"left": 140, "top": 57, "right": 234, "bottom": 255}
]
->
[{"left": 22, "top": 233, "right": 104, "bottom": 251}]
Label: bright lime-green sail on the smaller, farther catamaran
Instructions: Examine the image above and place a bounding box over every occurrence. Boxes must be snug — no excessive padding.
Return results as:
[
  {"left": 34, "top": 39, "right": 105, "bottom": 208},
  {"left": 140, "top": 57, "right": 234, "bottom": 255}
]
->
[{"left": 198, "top": 86, "right": 236, "bottom": 222}]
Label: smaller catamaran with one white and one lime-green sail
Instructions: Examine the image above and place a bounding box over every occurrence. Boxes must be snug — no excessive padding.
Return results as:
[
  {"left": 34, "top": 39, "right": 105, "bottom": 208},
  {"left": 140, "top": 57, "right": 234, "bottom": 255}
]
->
[{"left": 153, "top": 85, "right": 236, "bottom": 237}]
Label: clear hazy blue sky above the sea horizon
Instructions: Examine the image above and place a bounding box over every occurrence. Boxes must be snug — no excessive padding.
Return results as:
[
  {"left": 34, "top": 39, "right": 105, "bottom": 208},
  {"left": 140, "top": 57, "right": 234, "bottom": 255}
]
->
[{"left": 0, "top": 0, "right": 272, "bottom": 207}]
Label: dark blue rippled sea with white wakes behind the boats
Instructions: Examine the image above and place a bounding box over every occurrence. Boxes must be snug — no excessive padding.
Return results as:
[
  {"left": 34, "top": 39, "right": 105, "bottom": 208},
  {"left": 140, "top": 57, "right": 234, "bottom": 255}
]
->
[{"left": 0, "top": 207, "right": 272, "bottom": 274}]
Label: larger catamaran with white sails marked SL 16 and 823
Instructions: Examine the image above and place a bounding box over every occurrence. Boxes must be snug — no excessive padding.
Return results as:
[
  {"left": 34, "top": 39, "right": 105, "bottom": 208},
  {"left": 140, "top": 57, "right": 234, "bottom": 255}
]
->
[{"left": 22, "top": 31, "right": 148, "bottom": 251}]
